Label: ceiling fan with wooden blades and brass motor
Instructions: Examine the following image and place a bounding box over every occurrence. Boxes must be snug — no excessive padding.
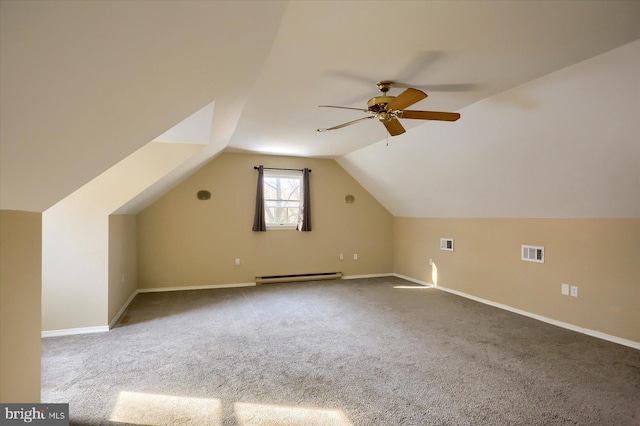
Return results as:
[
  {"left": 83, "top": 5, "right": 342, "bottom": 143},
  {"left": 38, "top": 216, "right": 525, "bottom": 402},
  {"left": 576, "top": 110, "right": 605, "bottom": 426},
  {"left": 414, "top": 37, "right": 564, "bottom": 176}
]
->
[{"left": 318, "top": 80, "right": 460, "bottom": 136}]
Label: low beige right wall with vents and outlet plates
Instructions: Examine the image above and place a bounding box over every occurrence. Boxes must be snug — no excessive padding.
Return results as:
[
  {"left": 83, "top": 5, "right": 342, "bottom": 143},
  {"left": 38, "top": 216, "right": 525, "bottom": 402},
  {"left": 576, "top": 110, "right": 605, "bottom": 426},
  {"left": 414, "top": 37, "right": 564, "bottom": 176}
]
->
[{"left": 394, "top": 217, "right": 640, "bottom": 342}]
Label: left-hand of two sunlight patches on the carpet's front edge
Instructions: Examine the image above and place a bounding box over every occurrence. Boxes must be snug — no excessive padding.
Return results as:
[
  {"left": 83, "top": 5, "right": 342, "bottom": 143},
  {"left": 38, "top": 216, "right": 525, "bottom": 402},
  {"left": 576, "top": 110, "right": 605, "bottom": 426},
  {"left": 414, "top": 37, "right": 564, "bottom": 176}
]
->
[{"left": 109, "top": 391, "right": 222, "bottom": 426}]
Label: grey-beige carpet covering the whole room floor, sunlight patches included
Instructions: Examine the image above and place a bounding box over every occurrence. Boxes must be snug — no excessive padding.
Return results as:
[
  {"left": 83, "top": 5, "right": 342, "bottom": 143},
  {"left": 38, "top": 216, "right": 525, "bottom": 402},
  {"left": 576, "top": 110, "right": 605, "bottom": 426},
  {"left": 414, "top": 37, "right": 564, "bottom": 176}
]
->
[{"left": 42, "top": 277, "right": 640, "bottom": 426}]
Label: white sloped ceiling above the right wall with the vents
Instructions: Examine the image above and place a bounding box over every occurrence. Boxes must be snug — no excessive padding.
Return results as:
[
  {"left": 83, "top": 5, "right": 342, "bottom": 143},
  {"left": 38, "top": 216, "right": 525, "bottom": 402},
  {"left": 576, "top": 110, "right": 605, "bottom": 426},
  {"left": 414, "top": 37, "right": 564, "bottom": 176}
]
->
[{"left": 338, "top": 41, "right": 640, "bottom": 218}]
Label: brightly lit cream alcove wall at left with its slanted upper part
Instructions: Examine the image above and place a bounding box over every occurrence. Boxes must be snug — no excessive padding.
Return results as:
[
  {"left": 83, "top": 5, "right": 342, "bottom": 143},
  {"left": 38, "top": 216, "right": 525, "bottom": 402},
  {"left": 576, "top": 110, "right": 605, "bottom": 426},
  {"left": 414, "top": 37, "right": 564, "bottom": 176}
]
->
[{"left": 42, "top": 142, "right": 202, "bottom": 332}]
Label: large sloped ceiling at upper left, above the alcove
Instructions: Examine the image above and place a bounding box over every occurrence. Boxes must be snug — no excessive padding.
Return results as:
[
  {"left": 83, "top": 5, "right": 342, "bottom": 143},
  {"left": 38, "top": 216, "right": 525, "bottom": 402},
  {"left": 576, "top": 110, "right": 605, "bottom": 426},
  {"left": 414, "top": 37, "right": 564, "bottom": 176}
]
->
[{"left": 0, "top": 0, "right": 286, "bottom": 211}]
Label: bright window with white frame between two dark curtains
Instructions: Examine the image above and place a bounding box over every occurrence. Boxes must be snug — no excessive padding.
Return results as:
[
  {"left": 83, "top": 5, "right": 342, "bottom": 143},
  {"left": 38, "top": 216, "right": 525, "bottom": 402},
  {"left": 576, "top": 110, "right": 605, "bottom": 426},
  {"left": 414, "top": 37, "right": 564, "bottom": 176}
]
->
[{"left": 264, "top": 170, "right": 303, "bottom": 229}]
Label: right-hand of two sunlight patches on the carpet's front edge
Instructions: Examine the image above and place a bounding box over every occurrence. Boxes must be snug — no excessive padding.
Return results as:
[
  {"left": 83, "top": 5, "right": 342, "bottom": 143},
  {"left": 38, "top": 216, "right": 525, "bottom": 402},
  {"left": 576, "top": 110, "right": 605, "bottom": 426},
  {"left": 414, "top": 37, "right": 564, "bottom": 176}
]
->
[{"left": 234, "top": 402, "right": 352, "bottom": 426}]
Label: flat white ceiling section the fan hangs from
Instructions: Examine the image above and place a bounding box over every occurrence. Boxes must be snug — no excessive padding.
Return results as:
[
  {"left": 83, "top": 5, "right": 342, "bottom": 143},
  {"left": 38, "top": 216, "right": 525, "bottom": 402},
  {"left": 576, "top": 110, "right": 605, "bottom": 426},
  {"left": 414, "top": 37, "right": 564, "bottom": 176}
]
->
[{"left": 230, "top": 1, "right": 640, "bottom": 157}]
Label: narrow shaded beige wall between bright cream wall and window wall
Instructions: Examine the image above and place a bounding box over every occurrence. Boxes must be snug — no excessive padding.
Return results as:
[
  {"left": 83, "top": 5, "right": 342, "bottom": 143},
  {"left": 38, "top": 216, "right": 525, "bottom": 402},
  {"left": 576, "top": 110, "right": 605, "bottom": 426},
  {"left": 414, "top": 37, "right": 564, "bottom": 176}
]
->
[{"left": 109, "top": 215, "right": 138, "bottom": 324}]
